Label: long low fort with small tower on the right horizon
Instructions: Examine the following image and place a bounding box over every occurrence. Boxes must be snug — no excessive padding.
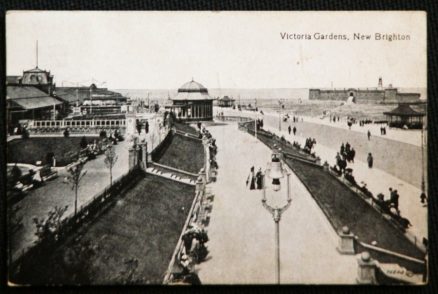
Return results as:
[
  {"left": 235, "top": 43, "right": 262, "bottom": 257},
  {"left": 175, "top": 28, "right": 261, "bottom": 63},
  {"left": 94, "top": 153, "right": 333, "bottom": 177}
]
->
[{"left": 309, "top": 78, "right": 421, "bottom": 104}]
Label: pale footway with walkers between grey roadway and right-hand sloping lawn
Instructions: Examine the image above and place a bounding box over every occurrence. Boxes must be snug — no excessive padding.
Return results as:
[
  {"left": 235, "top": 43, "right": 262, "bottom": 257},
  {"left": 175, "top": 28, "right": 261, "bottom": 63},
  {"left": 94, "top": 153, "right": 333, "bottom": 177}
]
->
[{"left": 265, "top": 127, "right": 428, "bottom": 246}]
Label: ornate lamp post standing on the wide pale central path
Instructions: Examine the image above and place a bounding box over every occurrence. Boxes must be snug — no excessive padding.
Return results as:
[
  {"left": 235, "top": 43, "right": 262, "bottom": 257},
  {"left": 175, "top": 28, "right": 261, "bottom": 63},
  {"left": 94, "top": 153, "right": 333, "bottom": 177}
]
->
[{"left": 262, "top": 149, "right": 292, "bottom": 284}]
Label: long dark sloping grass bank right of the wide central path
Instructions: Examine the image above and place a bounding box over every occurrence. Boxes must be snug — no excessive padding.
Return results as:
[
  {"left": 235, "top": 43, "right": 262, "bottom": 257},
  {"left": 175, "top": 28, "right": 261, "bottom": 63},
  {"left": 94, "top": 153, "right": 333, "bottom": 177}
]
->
[{"left": 240, "top": 120, "right": 424, "bottom": 272}]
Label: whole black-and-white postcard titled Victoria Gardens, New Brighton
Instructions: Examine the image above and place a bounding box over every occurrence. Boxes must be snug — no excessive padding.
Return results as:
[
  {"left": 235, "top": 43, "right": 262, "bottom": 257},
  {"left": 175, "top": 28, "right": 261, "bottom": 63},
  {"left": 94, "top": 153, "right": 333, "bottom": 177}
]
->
[{"left": 6, "top": 11, "right": 429, "bottom": 286}]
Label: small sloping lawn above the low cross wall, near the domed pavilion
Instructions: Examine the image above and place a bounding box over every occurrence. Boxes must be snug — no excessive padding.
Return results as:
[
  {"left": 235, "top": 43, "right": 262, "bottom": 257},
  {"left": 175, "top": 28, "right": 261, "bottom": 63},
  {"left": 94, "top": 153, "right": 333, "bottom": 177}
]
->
[{"left": 154, "top": 134, "right": 204, "bottom": 173}]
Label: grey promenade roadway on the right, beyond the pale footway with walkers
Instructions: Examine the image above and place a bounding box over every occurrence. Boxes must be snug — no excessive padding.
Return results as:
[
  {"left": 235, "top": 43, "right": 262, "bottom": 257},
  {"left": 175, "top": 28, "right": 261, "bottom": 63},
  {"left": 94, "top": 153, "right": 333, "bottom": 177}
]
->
[{"left": 217, "top": 109, "right": 427, "bottom": 188}]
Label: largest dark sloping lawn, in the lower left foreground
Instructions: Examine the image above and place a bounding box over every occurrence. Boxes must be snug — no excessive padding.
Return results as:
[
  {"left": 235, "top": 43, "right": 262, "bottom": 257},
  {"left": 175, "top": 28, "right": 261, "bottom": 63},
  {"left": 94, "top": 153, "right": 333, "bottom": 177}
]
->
[{"left": 13, "top": 175, "right": 195, "bottom": 285}]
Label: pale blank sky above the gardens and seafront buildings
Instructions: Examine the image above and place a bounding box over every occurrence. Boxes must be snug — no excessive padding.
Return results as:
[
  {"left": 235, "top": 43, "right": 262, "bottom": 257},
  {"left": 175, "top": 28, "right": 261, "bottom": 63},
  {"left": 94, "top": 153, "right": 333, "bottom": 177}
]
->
[{"left": 6, "top": 11, "right": 427, "bottom": 89}]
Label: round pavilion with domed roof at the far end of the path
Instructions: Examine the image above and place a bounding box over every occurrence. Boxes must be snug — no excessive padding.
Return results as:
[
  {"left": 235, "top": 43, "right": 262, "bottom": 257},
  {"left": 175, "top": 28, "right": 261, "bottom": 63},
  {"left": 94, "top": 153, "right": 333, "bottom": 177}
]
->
[{"left": 169, "top": 79, "right": 214, "bottom": 121}]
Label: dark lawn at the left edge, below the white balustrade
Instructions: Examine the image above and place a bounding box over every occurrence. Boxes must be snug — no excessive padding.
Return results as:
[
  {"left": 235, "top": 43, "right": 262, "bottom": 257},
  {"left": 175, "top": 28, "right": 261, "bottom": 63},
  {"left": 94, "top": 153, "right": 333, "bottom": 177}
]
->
[{"left": 7, "top": 137, "right": 99, "bottom": 166}]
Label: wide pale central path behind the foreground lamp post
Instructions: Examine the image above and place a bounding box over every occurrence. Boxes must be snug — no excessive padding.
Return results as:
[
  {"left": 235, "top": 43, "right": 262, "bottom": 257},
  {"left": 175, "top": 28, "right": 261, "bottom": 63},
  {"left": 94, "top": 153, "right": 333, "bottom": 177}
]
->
[{"left": 198, "top": 123, "right": 357, "bottom": 284}]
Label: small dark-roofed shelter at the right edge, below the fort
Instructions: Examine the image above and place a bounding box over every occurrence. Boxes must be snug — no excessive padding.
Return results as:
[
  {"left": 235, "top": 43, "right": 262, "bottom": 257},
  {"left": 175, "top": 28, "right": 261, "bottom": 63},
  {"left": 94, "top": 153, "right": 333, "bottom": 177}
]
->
[{"left": 383, "top": 104, "right": 425, "bottom": 129}]
